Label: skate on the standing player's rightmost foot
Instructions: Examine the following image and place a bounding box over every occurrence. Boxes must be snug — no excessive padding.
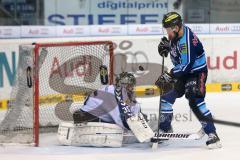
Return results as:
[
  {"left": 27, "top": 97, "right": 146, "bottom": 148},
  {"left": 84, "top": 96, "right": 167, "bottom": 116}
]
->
[{"left": 206, "top": 133, "right": 222, "bottom": 149}]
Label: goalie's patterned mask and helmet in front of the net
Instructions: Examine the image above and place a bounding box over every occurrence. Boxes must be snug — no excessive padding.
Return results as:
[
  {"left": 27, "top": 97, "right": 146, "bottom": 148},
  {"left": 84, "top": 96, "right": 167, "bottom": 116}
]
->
[{"left": 116, "top": 72, "right": 136, "bottom": 90}]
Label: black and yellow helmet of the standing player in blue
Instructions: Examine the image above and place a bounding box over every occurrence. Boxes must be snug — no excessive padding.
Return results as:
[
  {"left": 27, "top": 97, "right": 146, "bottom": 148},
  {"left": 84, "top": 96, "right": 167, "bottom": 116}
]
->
[{"left": 162, "top": 12, "right": 182, "bottom": 28}]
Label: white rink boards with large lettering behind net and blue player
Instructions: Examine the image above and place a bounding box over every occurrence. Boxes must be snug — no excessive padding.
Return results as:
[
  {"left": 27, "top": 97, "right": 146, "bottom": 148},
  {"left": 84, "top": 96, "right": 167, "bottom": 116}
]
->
[{"left": 0, "top": 35, "right": 240, "bottom": 103}]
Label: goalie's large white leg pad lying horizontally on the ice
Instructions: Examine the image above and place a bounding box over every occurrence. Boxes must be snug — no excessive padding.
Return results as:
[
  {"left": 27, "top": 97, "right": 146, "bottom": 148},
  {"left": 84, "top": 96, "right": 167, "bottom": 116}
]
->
[{"left": 58, "top": 122, "right": 123, "bottom": 147}]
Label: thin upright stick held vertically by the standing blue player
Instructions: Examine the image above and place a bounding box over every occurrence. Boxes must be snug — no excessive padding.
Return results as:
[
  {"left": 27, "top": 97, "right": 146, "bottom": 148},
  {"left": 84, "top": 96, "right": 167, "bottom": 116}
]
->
[{"left": 152, "top": 56, "right": 164, "bottom": 149}]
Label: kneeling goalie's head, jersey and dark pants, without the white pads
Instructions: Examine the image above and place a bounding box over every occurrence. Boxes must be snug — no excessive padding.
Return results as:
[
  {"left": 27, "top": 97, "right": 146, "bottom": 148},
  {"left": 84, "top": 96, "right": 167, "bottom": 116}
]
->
[{"left": 73, "top": 72, "right": 140, "bottom": 128}]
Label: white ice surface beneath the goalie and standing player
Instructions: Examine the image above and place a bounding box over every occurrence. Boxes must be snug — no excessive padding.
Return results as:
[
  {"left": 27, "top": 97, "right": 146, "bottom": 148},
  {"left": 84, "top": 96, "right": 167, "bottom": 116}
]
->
[{"left": 0, "top": 92, "right": 240, "bottom": 160}]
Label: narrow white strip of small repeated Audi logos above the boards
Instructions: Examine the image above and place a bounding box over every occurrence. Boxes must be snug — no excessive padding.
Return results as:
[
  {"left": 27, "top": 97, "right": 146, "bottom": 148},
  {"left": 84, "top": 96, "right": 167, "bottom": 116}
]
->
[{"left": 0, "top": 23, "right": 240, "bottom": 39}]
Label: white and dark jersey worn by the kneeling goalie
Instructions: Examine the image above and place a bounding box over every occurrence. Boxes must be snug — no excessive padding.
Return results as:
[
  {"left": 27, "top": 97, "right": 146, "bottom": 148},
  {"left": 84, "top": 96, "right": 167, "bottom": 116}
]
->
[{"left": 81, "top": 85, "right": 140, "bottom": 129}]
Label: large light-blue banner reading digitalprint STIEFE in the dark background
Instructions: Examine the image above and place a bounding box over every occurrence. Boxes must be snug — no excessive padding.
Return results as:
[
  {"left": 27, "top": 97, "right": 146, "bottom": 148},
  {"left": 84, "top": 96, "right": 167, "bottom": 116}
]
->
[{"left": 44, "top": 0, "right": 170, "bottom": 25}]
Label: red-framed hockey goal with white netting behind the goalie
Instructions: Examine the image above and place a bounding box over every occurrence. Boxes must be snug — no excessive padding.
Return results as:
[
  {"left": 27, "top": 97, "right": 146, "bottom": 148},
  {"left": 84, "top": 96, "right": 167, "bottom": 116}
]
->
[{"left": 0, "top": 41, "right": 113, "bottom": 146}]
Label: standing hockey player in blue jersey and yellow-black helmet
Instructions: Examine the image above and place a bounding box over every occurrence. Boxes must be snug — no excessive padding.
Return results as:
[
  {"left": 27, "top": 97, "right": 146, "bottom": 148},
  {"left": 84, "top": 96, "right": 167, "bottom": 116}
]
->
[{"left": 156, "top": 12, "right": 221, "bottom": 148}]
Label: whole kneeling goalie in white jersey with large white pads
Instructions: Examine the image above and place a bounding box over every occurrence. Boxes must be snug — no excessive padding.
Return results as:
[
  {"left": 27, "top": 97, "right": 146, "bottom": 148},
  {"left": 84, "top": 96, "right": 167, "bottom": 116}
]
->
[{"left": 58, "top": 72, "right": 154, "bottom": 147}]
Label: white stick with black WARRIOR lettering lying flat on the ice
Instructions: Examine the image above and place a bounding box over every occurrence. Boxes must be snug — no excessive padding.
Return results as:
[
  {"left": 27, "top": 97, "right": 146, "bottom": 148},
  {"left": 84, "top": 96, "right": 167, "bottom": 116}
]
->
[{"left": 151, "top": 129, "right": 205, "bottom": 143}]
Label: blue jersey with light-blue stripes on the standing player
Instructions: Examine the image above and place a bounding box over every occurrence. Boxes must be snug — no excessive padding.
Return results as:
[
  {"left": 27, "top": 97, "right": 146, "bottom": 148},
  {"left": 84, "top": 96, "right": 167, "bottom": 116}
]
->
[{"left": 170, "top": 25, "right": 207, "bottom": 77}]
